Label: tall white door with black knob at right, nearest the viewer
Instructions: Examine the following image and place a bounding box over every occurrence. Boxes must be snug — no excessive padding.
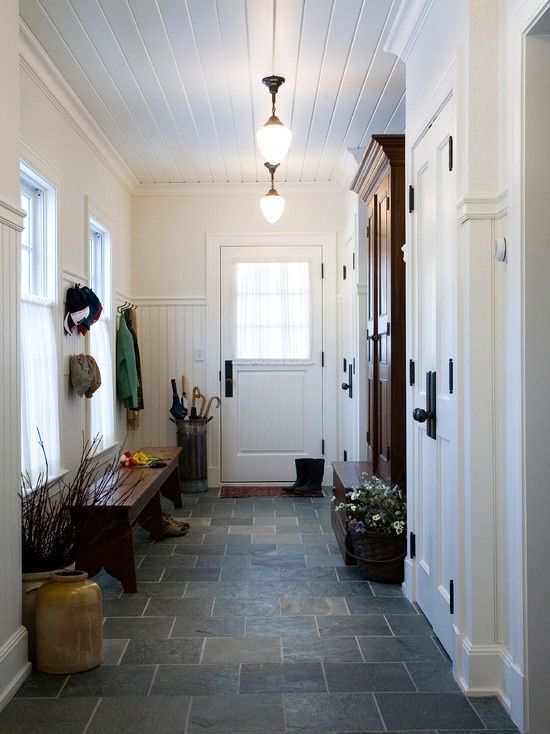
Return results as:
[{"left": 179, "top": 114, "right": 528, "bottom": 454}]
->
[{"left": 409, "top": 101, "right": 458, "bottom": 659}]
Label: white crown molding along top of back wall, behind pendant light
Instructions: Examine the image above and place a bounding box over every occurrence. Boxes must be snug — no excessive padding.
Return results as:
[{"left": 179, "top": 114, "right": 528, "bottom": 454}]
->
[{"left": 132, "top": 181, "right": 344, "bottom": 197}]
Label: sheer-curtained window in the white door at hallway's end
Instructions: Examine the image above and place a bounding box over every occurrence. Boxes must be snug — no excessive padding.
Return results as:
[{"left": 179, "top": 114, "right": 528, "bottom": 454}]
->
[{"left": 235, "top": 262, "right": 311, "bottom": 360}]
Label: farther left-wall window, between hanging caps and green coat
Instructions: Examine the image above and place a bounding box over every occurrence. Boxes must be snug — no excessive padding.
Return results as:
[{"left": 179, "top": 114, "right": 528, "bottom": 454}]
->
[{"left": 89, "top": 219, "right": 115, "bottom": 449}]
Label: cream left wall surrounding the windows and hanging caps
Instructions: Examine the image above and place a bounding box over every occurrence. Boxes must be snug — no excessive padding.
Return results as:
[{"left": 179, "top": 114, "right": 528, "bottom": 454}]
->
[{"left": 20, "top": 47, "right": 132, "bottom": 484}]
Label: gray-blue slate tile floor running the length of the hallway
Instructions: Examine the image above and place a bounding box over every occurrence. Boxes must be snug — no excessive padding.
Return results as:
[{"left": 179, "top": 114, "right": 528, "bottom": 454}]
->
[{"left": 0, "top": 490, "right": 516, "bottom": 734}]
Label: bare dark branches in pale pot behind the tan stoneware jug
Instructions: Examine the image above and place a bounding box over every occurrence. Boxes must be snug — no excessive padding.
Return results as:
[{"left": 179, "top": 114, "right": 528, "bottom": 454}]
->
[{"left": 20, "top": 433, "right": 140, "bottom": 657}]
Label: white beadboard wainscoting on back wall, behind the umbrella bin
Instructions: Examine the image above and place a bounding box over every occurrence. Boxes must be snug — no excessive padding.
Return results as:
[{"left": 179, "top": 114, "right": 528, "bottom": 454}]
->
[{"left": 126, "top": 297, "right": 206, "bottom": 448}]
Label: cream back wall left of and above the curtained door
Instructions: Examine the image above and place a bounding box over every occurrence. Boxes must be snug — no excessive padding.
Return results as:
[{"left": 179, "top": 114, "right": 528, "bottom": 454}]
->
[{"left": 128, "top": 184, "right": 349, "bottom": 466}]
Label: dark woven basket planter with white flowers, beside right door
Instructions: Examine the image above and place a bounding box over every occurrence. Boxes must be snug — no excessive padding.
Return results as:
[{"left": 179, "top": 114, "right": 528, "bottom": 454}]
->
[{"left": 335, "top": 474, "right": 407, "bottom": 583}]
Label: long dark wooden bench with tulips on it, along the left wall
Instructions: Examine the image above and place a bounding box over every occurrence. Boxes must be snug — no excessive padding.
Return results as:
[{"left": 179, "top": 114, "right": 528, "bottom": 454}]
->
[{"left": 75, "top": 447, "right": 182, "bottom": 593}]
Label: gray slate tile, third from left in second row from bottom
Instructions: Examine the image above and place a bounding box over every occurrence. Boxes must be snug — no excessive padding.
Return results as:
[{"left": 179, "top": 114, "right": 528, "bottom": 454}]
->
[{"left": 150, "top": 665, "right": 239, "bottom": 696}]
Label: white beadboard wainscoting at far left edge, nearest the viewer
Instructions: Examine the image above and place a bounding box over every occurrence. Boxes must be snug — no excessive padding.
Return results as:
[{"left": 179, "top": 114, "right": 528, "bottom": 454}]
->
[{"left": 0, "top": 202, "right": 30, "bottom": 708}]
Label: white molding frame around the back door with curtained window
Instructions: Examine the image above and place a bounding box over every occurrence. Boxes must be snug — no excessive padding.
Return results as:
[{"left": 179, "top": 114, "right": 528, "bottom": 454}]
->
[{"left": 206, "top": 232, "right": 337, "bottom": 487}]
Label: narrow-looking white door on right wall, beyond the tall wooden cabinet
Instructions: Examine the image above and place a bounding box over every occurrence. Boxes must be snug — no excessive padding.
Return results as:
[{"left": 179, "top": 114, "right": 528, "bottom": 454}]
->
[{"left": 338, "top": 235, "right": 359, "bottom": 461}]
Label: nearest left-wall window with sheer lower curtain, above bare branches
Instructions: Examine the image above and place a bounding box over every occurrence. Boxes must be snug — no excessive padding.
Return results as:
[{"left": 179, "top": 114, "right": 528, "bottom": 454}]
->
[{"left": 21, "top": 164, "right": 61, "bottom": 483}]
